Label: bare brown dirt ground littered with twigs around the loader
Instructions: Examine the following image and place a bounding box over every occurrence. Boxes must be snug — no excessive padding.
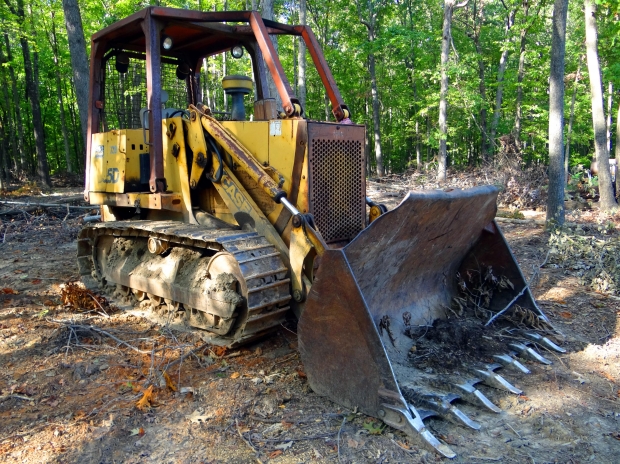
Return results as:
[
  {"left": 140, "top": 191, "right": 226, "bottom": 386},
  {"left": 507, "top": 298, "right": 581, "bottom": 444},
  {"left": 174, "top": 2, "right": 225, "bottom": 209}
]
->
[{"left": 0, "top": 178, "right": 620, "bottom": 463}]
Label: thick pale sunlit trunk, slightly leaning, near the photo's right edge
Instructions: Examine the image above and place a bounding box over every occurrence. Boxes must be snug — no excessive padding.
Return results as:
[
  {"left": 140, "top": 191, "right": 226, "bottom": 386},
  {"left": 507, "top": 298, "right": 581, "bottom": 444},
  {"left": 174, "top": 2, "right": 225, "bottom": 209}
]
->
[{"left": 585, "top": 0, "right": 618, "bottom": 211}]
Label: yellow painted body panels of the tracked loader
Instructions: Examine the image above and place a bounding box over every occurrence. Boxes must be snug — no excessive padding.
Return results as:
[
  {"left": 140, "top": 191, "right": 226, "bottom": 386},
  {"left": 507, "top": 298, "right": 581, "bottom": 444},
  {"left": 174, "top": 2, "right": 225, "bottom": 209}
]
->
[{"left": 90, "top": 117, "right": 336, "bottom": 239}]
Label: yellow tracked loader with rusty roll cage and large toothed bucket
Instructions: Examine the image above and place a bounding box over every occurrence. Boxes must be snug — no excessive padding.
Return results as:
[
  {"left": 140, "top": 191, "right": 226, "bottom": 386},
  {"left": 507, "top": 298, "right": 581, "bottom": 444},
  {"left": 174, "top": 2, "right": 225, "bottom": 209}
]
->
[{"left": 78, "top": 7, "right": 562, "bottom": 458}]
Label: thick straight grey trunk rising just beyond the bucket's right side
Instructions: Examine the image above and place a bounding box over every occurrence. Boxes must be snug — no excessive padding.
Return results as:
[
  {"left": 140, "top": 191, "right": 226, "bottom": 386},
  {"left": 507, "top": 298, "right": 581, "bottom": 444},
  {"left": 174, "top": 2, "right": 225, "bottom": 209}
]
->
[{"left": 547, "top": 0, "right": 568, "bottom": 225}]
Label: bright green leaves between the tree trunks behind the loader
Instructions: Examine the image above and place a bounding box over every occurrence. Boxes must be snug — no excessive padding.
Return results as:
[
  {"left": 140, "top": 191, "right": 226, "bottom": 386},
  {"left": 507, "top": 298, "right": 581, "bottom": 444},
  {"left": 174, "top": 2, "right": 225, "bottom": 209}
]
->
[{"left": 0, "top": 0, "right": 620, "bottom": 179}]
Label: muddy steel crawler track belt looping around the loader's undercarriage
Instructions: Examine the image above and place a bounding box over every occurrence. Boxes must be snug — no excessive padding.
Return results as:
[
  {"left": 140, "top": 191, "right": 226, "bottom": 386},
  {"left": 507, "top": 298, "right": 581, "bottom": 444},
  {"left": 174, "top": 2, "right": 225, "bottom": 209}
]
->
[{"left": 78, "top": 221, "right": 291, "bottom": 346}]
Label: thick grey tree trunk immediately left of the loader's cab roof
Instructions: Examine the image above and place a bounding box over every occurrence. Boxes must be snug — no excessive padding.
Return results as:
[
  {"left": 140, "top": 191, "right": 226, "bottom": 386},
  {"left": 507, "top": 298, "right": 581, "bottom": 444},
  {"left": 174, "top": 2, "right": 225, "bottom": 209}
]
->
[{"left": 62, "top": 0, "right": 90, "bottom": 152}]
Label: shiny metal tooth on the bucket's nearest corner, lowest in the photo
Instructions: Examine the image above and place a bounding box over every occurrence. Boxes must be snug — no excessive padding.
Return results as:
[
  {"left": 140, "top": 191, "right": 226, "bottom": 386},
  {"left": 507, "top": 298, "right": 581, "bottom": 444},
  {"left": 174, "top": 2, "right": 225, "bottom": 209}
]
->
[{"left": 379, "top": 404, "right": 456, "bottom": 459}]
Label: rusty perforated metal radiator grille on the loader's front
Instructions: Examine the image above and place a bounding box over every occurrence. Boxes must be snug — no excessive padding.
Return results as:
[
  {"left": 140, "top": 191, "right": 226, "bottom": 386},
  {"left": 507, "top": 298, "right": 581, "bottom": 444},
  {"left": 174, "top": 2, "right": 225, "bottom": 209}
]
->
[{"left": 309, "top": 129, "right": 366, "bottom": 243}]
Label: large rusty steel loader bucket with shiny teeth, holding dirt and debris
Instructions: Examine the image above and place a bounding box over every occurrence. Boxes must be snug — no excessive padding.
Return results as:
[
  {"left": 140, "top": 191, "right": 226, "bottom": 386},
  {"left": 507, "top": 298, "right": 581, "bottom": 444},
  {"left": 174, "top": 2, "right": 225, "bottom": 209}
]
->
[{"left": 298, "top": 186, "right": 556, "bottom": 457}]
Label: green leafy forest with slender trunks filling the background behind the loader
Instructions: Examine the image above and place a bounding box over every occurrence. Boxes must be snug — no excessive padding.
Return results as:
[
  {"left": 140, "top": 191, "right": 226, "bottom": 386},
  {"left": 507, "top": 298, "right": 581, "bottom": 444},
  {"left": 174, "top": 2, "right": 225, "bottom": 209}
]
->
[{"left": 0, "top": 0, "right": 620, "bottom": 202}]
